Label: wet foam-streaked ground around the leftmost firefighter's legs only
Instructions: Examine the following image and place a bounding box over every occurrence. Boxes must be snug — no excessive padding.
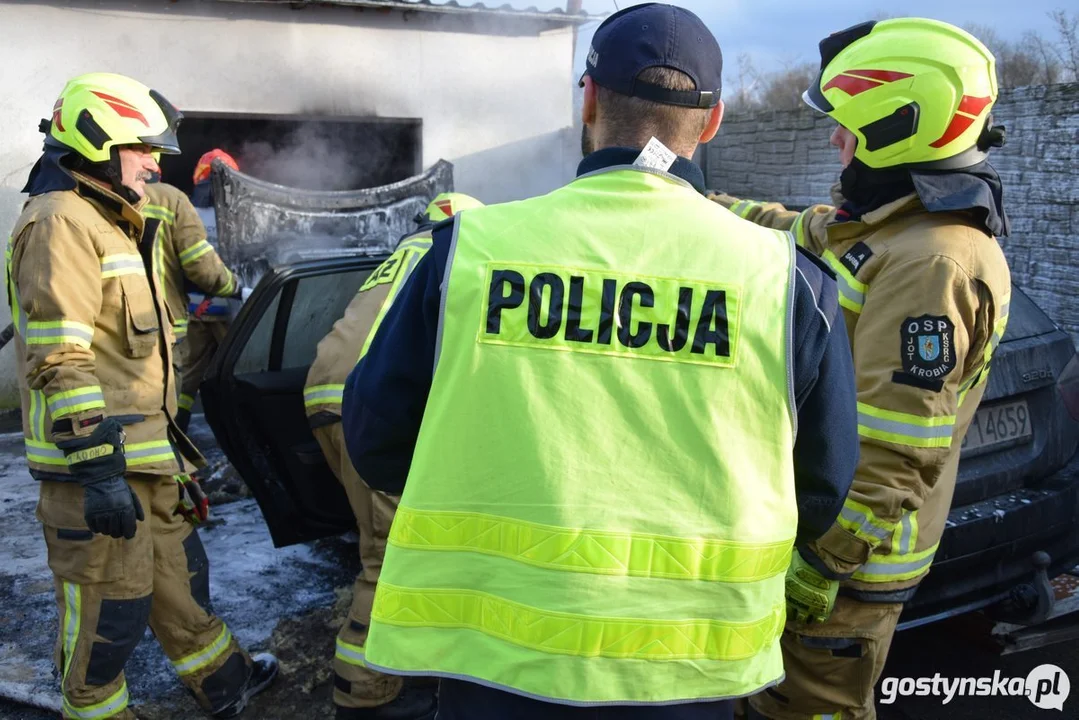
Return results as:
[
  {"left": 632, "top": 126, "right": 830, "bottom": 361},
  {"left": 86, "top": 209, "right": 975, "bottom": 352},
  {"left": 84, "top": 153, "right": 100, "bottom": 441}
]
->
[{"left": 0, "top": 418, "right": 359, "bottom": 720}]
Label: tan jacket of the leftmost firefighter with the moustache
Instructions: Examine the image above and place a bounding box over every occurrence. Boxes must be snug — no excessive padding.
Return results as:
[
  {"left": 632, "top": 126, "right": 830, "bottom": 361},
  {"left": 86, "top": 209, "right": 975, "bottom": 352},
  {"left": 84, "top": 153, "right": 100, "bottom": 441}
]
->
[{"left": 6, "top": 174, "right": 204, "bottom": 479}]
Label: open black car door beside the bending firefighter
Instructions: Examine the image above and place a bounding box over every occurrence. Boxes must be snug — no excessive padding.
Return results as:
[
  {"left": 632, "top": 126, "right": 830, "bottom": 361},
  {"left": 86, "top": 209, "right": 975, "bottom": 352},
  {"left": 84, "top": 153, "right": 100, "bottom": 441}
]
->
[{"left": 201, "top": 255, "right": 386, "bottom": 547}]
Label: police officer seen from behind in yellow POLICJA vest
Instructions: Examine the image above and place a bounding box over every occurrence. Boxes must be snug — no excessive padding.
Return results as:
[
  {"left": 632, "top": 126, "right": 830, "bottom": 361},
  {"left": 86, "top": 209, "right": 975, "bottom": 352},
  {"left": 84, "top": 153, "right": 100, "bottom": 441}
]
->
[{"left": 343, "top": 3, "right": 857, "bottom": 720}]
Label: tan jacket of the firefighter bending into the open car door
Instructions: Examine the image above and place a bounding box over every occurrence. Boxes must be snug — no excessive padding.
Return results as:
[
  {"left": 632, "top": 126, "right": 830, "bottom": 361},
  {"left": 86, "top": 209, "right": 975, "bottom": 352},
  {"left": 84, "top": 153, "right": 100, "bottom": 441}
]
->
[{"left": 303, "top": 230, "right": 431, "bottom": 424}]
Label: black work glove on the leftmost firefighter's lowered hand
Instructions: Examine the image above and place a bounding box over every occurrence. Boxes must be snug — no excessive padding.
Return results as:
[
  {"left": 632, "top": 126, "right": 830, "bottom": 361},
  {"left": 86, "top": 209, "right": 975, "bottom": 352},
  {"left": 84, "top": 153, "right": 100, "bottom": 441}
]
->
[{"left": 56, "top": 418, "right": 146, "bottom": 540}]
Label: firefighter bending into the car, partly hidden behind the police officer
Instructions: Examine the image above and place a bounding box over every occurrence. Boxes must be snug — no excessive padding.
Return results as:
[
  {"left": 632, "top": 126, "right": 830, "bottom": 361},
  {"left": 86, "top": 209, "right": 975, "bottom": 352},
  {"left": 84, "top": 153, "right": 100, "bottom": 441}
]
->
[{"left": 303, "top": 192, "right": 482, "bottom": 720}]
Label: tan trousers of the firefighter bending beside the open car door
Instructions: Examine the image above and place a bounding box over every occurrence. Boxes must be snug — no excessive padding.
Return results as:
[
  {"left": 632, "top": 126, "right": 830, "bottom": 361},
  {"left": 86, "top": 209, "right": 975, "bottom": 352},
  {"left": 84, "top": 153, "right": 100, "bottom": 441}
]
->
[{"left": 313, "top": 422, "right": 404, "bottom": 707}]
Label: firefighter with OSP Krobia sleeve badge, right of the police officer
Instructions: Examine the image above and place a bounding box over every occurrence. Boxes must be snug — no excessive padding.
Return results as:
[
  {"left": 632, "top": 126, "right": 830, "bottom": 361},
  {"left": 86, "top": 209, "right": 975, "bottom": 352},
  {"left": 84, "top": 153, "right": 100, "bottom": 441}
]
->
[{"left": 715, "top": 18, "right": 1011, "bottom": 720}]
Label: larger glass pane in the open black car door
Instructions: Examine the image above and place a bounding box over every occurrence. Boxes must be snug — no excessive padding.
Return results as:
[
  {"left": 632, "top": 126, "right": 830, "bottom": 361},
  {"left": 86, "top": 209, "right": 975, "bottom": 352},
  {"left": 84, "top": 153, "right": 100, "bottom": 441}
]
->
[{"left": 278, "top": 270, "right": 371, "bottom": 370}]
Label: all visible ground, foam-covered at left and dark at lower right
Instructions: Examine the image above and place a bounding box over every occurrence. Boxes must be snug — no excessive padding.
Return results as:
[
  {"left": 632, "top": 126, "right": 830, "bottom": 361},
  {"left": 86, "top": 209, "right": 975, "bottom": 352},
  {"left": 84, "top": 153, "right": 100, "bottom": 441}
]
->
[{"left": 0, "top": 418, "right": 1079, "bottom": 720}]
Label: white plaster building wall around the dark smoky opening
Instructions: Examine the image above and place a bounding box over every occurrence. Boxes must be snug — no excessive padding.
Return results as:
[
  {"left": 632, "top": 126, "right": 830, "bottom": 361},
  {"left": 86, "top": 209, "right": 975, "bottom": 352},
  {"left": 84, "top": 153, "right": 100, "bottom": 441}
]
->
[{"left": 0, "top": 0, "right": 579, "bottom": 407}]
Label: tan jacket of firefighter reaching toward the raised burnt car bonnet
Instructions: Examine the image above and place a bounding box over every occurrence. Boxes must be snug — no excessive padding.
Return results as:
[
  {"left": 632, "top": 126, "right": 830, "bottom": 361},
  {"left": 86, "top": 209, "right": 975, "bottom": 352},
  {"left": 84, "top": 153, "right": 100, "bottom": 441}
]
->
[{"left": 142, "top": 182, "right": 240, "bottom": 340}]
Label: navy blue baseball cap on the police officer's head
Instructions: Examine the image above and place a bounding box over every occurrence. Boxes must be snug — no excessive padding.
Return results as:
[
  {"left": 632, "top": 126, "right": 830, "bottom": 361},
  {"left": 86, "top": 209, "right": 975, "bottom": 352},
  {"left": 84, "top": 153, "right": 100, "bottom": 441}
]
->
[{"left": 581, "top": 2, "right": 723, "bottom": 108}]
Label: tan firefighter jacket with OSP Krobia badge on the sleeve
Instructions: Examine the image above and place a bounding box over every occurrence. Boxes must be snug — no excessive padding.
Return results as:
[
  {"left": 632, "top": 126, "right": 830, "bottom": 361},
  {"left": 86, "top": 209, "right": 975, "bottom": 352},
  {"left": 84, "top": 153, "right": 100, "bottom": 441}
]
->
[{"left": 712, "top": 186, "right": 1011, "bottom": 597}]
